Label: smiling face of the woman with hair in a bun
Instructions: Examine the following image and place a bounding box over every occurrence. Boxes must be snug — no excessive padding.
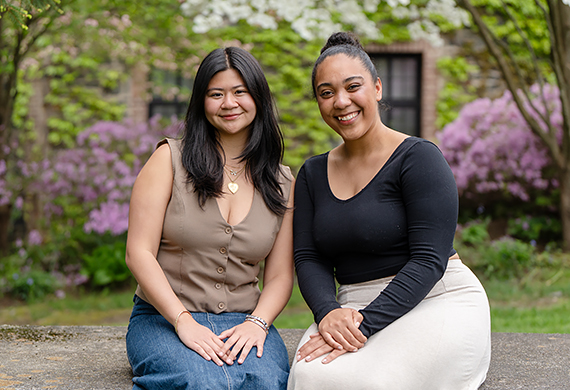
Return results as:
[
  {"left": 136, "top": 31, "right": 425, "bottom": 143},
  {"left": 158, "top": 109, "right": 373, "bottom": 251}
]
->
[{"left": 315, "top": 54, "right": 382, "bottom": 142}]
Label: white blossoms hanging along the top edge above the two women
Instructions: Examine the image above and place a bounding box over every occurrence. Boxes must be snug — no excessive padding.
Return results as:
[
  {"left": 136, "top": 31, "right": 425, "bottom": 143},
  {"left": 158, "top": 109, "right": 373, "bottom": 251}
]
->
[{"left": 180, "top": 0, "right": 452, "bottom": 44}]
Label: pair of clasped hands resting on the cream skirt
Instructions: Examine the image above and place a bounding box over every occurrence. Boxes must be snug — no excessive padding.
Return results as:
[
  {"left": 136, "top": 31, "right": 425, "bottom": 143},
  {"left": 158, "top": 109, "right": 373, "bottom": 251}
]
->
[{"left": 297, "top": 309, "right": 368, "bottom": 363}]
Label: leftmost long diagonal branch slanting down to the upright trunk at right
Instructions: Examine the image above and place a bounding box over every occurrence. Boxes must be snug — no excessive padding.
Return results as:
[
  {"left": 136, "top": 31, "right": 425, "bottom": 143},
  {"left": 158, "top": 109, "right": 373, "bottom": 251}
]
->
[{"left": 457, "top": 0, "right": 565, "bottom": 168}]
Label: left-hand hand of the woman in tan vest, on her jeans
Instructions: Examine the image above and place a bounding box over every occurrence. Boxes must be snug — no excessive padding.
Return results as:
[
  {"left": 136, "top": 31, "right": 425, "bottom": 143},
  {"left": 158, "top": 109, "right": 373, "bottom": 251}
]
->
[{"left": 178, "top": 313, "right": 224, "bottom": 366}]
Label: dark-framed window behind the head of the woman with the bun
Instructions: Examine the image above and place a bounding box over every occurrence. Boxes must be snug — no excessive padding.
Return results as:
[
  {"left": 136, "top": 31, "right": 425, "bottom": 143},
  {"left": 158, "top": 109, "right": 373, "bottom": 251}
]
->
[{"left": 370, "top": 53, "right": 421, "bottom": 137}]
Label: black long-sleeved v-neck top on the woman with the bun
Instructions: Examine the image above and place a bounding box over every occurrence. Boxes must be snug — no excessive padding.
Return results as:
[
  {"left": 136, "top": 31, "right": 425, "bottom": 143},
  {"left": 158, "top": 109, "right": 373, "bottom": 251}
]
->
[{"left": 294, "top": 137, "right": 458, "bottom": 337}]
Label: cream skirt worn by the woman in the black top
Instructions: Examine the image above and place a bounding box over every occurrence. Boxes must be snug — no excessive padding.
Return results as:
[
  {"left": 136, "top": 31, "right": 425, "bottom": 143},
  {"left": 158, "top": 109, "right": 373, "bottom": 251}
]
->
[{"left": 287, "top": 259, "right": 491, "bottom": 390}]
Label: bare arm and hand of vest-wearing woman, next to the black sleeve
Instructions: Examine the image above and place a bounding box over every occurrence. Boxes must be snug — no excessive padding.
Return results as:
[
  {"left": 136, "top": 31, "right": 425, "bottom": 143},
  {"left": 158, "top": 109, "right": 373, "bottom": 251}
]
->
[{"left": 219, "top": 178, "right": 294, "bottom": 364}]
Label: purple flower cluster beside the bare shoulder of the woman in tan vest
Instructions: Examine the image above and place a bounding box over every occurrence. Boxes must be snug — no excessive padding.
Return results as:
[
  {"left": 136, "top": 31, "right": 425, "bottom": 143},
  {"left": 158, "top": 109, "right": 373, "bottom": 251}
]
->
[{"left": 36, "top": 118, "right": 178, "bottom": 235}]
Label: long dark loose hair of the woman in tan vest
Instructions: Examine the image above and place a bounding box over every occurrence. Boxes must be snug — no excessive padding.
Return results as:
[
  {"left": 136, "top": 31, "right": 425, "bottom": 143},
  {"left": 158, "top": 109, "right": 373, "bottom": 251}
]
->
[{"left": 182, "top": 47, "right": 287, "bottom": 215}]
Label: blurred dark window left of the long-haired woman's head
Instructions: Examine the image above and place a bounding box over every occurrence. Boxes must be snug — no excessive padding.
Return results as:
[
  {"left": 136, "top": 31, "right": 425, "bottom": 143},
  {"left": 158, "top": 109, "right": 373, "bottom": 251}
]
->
[{"left": 148, "top": 69, "right": 193, "bottom": 118}]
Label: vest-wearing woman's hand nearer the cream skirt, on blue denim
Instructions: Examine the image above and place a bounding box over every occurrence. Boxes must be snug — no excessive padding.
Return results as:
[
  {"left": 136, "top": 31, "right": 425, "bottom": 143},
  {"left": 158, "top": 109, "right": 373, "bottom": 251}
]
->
[{"left": 218, "top": 321, "right": 266, "bottom": 364}]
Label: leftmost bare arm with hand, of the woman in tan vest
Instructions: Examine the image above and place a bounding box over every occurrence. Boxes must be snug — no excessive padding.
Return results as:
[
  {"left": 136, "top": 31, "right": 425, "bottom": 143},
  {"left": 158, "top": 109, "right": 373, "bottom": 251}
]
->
[{"left": 126, "top": 145, "right": 223, "bottom": 365}]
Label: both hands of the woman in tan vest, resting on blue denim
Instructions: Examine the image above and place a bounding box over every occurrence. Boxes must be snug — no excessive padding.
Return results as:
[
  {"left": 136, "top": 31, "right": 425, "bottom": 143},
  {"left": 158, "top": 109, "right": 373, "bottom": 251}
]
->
[{"left": 178, "top": 321, "right": 266, "bottom": 366}]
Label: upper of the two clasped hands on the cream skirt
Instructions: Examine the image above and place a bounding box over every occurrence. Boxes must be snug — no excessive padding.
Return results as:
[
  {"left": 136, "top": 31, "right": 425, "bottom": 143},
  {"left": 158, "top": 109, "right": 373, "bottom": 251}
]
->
[{"left": 319, "top": 308, "right": 368, "bottom": 352}]
